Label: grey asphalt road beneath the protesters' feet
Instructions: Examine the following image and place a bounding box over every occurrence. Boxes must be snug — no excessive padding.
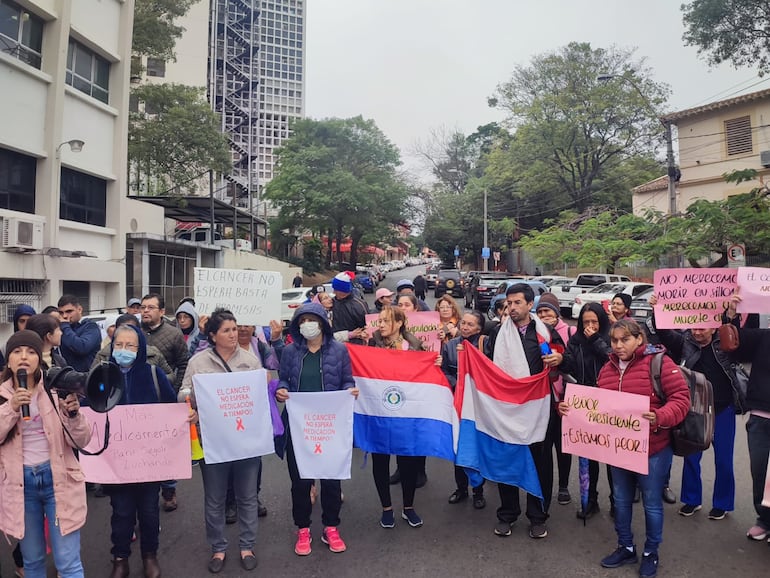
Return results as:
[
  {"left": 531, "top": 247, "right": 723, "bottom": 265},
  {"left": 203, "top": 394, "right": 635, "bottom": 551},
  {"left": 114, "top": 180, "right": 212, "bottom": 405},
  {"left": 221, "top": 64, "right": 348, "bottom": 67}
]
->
[{"left": 0, "top": 268, "right": 770, "bottom": 578}]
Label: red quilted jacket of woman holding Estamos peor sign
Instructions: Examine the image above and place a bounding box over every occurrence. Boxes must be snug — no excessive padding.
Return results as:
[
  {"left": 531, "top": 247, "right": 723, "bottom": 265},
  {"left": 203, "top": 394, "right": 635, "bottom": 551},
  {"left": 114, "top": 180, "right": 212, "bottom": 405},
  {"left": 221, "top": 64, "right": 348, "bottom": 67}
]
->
[{"left": 598, "top": 346, "right": 690, "bottom": 456}]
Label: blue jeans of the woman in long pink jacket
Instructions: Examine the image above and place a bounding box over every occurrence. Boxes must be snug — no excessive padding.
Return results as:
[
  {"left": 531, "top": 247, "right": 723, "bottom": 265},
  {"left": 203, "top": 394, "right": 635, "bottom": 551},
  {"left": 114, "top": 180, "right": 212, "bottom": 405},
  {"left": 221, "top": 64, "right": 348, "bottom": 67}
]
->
[{"left": 21, "top": 462, "right": 84, "bottom": 578}]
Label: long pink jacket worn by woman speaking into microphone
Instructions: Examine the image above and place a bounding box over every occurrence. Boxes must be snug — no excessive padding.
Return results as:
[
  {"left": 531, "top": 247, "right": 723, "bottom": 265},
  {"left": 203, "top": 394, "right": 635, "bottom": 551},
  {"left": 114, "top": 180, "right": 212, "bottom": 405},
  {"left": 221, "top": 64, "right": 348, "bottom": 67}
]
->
[{"left": 0, "top": 380, "right": 91, "bottom": 539}]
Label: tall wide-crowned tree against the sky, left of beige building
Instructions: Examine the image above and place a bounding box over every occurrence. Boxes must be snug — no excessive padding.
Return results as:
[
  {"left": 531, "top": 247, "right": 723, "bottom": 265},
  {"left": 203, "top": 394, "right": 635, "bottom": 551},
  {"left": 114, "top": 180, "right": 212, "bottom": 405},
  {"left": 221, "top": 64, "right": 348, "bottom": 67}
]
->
[{"left": 489, "top": 42, "right": 668, "bottom": 213}]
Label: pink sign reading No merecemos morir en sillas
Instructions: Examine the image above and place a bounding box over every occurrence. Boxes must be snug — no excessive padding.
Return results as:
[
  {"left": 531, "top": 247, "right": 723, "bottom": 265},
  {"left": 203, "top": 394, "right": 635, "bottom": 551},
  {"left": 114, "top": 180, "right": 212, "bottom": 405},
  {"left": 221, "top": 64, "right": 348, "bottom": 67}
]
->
[{"left": 655, "top": 268, "right": 738, "bottom": 329}]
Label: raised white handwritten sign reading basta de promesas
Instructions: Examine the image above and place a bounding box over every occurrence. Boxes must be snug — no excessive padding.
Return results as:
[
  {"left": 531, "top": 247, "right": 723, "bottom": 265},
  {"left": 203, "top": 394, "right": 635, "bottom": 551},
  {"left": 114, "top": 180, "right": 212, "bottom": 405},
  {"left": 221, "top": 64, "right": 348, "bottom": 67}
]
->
[{"left": 193, "top": 267, "right": 283, "bottom": 325}]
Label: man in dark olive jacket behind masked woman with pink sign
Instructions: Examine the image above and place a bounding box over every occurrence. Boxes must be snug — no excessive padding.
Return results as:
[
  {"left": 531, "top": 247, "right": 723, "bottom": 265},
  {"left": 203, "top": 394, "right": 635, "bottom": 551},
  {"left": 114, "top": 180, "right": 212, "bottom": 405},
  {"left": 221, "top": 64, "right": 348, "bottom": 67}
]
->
[{"left": 142, "top": 293, "right": 190, "bottom": 512}]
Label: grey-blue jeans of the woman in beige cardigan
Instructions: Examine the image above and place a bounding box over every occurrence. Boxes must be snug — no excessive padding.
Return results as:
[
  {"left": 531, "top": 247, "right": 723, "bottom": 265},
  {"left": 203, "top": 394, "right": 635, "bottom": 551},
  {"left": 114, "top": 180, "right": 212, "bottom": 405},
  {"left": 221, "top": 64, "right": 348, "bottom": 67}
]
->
[{"left": 200, "top": 458, "right": 260, "bottom": 554}]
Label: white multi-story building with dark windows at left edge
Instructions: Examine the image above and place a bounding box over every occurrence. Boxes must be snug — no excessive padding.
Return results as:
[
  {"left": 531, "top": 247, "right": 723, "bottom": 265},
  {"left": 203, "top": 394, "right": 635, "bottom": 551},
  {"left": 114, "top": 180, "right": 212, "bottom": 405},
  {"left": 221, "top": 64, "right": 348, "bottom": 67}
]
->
[{"left": 0, "top": 0, "right": 163, "bottom": 340}]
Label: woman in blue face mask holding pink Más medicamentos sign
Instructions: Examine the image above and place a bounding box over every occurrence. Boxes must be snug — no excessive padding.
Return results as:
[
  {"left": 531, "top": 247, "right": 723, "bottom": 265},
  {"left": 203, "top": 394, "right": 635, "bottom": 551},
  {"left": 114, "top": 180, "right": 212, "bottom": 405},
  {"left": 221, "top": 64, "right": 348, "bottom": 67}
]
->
[{"left": 103, "top": 324, "right": 176, "bottom": 578}]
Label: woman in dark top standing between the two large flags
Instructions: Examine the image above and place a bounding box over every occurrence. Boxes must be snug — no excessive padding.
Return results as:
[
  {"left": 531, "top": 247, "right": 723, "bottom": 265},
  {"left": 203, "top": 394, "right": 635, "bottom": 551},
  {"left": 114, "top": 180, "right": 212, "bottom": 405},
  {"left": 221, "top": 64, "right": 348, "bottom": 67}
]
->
[{"left": 441, "top": 311, "right": 488, "bottom": 510}]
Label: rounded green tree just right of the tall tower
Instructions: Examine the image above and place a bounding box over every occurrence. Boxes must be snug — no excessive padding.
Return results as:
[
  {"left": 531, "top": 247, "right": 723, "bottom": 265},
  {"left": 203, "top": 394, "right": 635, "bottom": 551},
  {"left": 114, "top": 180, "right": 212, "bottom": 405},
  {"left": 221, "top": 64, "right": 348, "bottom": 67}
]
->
[{"left": 265, "top": 116, "right": 409, "bottom": 261}]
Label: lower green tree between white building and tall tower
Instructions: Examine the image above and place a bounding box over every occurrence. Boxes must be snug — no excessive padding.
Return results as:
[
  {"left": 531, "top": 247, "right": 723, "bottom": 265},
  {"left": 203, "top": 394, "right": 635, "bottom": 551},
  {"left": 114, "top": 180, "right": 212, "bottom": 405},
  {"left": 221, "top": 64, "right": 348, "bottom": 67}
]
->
[{"left": 128, "top": 84, "right": 232, "bottom": 194}]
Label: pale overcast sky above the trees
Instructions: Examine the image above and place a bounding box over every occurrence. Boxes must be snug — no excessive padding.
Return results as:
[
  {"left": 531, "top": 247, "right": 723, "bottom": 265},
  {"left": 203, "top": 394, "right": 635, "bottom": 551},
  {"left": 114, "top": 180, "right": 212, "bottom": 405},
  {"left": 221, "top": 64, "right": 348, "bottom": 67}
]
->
[{"left": 305, "top": 0, "right": 770, "bottom": 178}]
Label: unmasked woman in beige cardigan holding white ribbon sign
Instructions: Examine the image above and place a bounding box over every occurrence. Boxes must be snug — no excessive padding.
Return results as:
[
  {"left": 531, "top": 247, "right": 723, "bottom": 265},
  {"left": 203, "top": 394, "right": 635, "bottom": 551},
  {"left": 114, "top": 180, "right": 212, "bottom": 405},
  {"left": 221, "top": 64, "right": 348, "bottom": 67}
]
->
[{"left": 182, "top": 309, "right": 262, "bottom": 574}]
